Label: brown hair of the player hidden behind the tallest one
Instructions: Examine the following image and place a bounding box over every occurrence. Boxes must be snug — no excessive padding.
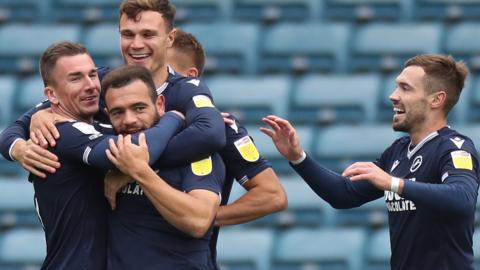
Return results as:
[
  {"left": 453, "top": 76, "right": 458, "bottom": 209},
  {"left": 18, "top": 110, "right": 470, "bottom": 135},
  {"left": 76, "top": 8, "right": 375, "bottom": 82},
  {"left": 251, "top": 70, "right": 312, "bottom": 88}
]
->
[{"left": 172, "top": 28, "right": 205, "bottom": 77}]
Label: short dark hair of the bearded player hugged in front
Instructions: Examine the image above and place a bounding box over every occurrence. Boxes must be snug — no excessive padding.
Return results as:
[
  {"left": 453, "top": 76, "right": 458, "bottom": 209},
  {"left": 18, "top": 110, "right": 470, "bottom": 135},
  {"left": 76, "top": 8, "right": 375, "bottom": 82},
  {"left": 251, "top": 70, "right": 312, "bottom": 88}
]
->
[{"left": 102, "top": 65, "right": 158, "bottom": 103}]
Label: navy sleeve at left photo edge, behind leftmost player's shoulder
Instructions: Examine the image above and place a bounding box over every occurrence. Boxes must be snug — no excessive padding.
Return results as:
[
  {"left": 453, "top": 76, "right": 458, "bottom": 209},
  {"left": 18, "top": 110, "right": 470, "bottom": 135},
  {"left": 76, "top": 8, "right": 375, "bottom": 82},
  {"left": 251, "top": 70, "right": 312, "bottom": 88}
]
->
[{"left": 0, "top": 101, "right": 50, "bottom": 161}]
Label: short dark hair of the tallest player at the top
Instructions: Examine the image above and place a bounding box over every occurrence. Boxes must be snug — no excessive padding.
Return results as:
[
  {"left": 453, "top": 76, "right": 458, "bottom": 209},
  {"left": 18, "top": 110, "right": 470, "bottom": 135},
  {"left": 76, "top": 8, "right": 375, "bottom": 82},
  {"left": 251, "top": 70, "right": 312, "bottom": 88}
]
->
[{"left": 119, "top": 0, "right": 176, "bottom": 31}]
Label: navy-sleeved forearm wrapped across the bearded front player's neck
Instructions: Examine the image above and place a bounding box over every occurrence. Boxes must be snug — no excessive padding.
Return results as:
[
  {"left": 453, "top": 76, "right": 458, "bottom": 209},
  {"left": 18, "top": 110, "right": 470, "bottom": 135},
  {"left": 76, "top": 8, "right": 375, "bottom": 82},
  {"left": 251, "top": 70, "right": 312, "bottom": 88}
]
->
[{"left": 87, "top": 113, "right": 183, "bottom": 170}]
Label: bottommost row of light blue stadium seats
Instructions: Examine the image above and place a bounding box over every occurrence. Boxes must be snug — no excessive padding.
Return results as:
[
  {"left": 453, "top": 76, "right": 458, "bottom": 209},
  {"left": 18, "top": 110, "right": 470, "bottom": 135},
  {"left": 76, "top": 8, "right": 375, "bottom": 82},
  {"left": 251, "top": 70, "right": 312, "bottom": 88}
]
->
[{"left": 0, "top": 224, "right": 480, "bottom": 270}]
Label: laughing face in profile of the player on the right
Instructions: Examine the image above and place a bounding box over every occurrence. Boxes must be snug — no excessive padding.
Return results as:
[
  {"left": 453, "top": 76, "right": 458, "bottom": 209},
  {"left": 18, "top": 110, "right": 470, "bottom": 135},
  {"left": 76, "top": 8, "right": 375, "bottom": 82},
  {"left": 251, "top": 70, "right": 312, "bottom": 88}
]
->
[{"left": 390, "top": 66, "right": 430, "bottom": 133}]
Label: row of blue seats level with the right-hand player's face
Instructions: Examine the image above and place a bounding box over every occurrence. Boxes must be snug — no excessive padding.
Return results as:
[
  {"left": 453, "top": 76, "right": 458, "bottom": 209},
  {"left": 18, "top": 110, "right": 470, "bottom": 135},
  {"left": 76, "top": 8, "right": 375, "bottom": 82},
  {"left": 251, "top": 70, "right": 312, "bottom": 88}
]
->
[{"left": 0, "top": 73, "right": 480, "bottom": 126}]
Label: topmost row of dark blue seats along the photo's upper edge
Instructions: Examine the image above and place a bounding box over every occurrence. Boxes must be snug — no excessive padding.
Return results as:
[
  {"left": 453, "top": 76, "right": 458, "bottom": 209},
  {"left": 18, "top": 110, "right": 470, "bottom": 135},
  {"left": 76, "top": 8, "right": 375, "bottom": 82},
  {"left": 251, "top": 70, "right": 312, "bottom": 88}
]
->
[{"left": 4, "top": 0, "right": 480, "bottom": 23}]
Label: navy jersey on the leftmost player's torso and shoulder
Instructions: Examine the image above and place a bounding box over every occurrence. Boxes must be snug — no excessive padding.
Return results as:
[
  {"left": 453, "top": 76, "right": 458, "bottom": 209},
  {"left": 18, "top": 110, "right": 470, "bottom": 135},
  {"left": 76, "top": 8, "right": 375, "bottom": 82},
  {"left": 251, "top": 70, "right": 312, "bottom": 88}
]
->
[{"left": 30, "top": 122, "right": 114, "bottom": 270}]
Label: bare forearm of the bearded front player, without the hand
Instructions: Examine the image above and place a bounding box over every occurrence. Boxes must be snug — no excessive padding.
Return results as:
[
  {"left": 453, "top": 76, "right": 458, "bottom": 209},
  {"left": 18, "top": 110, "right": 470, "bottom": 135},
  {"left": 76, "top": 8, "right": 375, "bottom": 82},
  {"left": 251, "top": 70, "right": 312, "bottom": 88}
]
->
[{"left": 131, "top": 167, "right": 217, "bottom": 238}]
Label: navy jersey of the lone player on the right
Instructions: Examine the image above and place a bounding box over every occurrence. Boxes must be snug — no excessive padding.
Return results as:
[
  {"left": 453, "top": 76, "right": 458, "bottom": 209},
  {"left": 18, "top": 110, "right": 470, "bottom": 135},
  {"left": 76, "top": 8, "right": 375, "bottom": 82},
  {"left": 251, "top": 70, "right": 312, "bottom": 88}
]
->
[{"left": 377, "top": 128, "right": 479, "bottom": 270}]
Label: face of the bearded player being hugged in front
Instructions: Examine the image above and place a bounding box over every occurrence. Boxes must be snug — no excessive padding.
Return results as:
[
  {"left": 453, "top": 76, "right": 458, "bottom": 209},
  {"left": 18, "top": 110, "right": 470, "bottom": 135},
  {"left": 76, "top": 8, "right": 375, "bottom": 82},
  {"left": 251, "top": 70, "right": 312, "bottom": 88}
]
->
[{"left": 105, "top": 80, "right": 164, "bottom": 134}]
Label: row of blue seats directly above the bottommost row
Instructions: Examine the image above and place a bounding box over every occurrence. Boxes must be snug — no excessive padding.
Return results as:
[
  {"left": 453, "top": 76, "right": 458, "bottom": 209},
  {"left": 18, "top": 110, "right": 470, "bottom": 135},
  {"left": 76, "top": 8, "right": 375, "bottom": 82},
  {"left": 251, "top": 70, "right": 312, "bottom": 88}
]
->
[{"left": 0, "top": 175, "right": 480, "bottom": 230}]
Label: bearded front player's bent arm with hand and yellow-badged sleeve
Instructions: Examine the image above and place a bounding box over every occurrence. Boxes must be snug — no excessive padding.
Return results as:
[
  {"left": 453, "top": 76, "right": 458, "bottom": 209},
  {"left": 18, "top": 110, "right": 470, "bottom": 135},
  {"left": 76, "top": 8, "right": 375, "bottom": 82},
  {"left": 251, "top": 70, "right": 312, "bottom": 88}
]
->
[{"left": 109, "top": 134, "right": 224, "bottom": 238}]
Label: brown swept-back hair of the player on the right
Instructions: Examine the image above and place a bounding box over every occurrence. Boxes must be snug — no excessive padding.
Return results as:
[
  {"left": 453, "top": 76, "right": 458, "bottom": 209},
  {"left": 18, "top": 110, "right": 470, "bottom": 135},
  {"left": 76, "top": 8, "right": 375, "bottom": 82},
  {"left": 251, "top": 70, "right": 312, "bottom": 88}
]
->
[{"left": 405, "top": 54, "right": 468, "bottom": 115}]
